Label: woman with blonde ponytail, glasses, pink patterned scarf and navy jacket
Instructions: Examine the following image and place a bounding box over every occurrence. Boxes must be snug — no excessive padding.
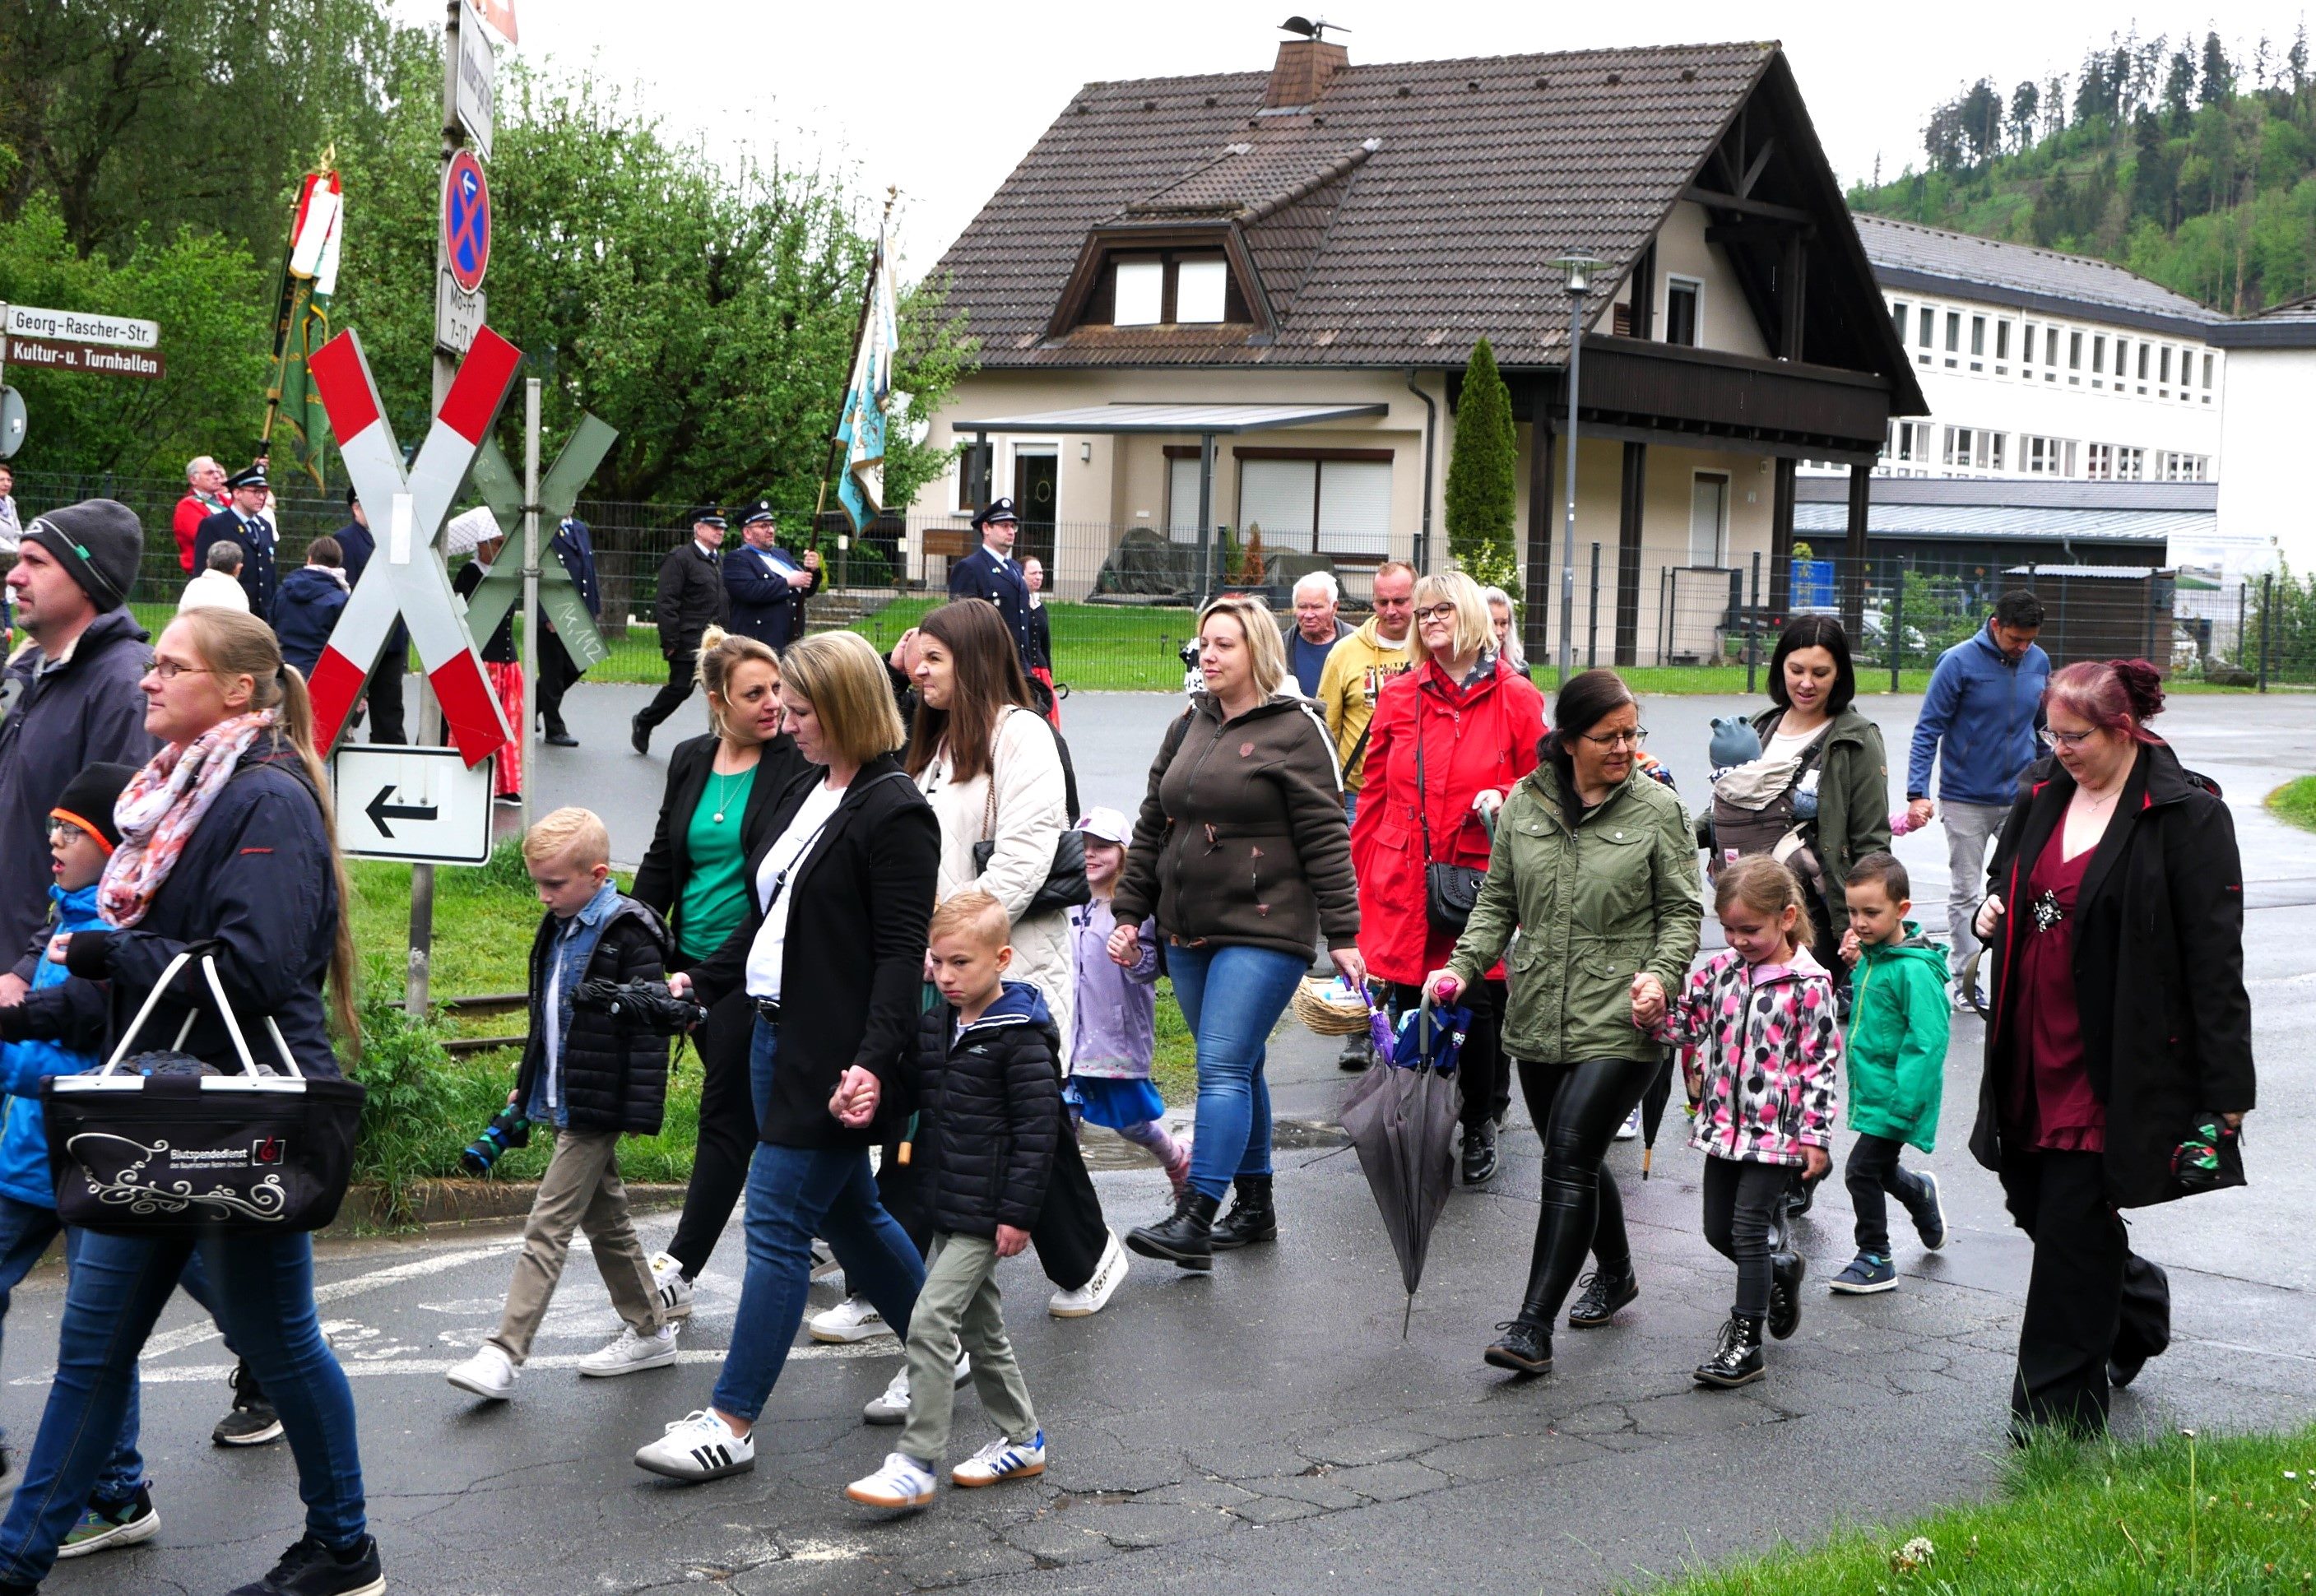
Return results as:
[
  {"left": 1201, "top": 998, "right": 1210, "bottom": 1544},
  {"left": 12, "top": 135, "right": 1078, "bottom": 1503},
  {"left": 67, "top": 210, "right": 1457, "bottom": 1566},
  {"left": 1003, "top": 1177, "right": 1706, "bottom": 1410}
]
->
[{"left": 0, "top": 610, "right": 384, "bottom": 1596}]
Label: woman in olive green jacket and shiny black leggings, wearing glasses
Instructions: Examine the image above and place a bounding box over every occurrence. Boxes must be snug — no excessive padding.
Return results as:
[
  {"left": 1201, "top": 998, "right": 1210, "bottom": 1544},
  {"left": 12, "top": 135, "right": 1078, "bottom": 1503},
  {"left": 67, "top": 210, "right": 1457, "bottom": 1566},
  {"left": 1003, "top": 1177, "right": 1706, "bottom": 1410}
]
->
[{"left": 1424, "top": 670, "right": 1705, "bottom": 1374}]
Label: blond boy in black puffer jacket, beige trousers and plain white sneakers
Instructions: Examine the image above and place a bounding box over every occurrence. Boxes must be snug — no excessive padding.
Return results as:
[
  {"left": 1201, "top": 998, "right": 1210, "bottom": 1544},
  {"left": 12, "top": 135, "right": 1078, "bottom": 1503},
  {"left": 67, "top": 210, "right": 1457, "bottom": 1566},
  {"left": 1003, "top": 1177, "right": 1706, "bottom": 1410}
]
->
[{"left": 447, "top": 809, "right": 676, "bottom": 1401}]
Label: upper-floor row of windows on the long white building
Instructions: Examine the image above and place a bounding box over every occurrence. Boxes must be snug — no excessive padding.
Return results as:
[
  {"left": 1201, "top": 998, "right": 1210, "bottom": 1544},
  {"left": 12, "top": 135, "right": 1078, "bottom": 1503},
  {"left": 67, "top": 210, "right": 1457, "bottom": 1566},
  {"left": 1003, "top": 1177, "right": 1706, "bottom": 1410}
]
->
[{"left": 1890, "top": 299, "right": 2219, "bottom": 406}]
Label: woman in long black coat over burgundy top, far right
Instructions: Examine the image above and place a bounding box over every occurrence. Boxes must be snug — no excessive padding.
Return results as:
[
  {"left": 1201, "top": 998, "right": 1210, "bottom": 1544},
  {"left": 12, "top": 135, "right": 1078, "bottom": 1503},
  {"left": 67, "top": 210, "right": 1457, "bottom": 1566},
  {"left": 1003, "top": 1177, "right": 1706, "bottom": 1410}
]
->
[{"left": 1971, "top": 660, "right": 2256, "bottom": 1439}]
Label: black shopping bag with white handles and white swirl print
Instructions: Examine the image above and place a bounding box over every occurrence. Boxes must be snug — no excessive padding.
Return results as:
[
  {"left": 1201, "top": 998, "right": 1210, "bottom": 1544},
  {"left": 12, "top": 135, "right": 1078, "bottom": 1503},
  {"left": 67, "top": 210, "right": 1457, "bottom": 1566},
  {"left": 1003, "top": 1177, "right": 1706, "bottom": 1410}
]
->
[{"left": 39, "top": 948, "right": 366, "bottom": 1237}]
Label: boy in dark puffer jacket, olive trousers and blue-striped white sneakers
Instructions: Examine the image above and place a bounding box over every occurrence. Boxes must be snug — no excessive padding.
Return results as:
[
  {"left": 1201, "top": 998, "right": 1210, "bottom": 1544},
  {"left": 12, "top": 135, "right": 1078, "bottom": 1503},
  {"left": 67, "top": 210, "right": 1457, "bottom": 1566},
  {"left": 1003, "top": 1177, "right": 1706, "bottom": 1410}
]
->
[{"left": 845, "top": 892, "right": 1063, "bottom": 1508}]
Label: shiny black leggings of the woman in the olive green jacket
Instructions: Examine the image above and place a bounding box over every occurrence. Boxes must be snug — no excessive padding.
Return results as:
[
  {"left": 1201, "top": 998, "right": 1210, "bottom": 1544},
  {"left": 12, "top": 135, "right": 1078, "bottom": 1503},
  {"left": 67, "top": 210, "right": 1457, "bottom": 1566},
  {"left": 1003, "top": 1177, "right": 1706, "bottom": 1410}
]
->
[{"left": 1520, "top": 1059, "right": 1663, "bottom": 1325}]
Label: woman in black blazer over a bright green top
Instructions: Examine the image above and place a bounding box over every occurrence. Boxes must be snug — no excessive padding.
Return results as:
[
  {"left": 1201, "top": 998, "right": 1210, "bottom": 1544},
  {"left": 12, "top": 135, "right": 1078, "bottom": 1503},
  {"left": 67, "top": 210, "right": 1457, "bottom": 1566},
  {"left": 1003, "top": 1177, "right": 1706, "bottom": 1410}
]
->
[{"left": 634, "top": 625, "right": 808, "bottom": 1318}]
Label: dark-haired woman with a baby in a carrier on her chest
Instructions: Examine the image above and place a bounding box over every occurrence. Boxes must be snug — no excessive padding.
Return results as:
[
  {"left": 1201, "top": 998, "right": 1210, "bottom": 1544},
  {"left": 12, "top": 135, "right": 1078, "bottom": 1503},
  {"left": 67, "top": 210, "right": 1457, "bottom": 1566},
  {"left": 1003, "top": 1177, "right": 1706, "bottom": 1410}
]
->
[{"left": 1753, "top": 616, "right": 1890, "bottom": 986}]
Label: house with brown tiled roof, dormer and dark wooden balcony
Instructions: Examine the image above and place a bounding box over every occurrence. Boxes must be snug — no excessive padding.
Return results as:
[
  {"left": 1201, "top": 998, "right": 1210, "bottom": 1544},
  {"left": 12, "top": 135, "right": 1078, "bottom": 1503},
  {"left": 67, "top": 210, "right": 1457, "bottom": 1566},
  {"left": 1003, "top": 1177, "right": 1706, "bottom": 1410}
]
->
[{"left": 910, "top": 37, "right": 1924, "bottom": 662}]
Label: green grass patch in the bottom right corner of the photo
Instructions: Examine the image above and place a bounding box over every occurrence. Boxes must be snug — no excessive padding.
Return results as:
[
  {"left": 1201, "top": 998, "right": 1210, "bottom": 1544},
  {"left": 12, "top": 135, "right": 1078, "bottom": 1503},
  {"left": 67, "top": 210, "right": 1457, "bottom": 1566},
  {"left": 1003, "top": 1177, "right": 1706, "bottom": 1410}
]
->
[{"left": 1628, "top": 1436, "right": 2316, "bottom": 1596}]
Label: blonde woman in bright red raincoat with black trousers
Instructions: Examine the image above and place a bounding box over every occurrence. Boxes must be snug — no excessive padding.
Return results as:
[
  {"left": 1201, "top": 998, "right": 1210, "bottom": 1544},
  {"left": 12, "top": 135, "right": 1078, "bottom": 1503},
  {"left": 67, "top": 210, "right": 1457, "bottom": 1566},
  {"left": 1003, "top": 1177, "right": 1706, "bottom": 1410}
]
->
[{"left": 1350, "top": 572, "right": 1545, "bottom": 1186}]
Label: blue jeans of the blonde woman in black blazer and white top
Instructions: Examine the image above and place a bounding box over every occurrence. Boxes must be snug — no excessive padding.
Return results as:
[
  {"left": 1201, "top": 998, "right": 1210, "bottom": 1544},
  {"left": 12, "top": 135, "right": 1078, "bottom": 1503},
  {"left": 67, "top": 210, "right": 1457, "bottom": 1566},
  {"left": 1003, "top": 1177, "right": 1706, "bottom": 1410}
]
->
[{"left": 711, "top": 1014, "right": 924, "bottom": 1422}]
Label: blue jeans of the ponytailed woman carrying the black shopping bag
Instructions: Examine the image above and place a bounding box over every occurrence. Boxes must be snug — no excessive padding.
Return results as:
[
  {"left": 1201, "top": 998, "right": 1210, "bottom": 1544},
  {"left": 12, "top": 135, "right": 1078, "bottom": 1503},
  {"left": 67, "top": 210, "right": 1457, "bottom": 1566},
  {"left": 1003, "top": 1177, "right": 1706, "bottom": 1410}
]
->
[{"left": 0, "top": 1232, "right": 366, "bottom": 1584}]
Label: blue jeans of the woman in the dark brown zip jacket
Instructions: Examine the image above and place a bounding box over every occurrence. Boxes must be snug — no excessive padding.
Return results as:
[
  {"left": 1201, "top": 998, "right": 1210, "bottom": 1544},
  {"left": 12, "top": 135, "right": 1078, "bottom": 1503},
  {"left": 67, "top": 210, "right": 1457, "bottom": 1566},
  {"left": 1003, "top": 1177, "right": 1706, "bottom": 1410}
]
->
[{"left": 1165, "top": 945, "right": 1311, "bottom": 1202}]
